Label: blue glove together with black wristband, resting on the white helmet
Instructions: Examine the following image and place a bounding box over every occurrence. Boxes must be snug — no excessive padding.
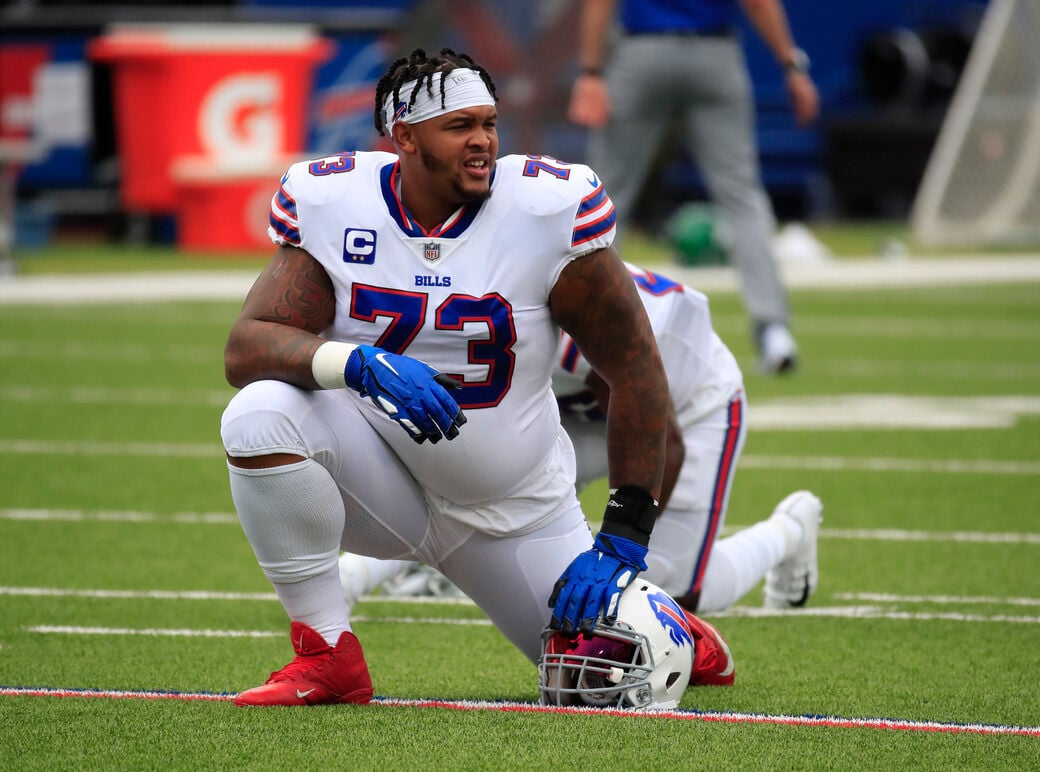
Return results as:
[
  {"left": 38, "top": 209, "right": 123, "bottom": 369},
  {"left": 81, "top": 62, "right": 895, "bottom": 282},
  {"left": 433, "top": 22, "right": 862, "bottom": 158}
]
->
[{"left": 549, "top": 486, "right": 657, "bottom": 636}]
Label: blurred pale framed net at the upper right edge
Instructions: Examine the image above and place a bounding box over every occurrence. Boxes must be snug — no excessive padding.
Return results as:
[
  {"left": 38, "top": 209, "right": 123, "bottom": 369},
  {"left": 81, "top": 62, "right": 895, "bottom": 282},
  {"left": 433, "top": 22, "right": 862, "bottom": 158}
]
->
[{"left": 910, "top": 0, "right": 1040, "bottom": 247}]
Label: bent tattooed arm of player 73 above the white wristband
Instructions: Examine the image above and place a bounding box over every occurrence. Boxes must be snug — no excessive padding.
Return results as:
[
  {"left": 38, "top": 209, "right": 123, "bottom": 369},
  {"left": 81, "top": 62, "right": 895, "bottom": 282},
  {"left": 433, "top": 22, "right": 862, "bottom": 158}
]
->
[{"left": 224, "top": 247, "right": 336, "bottom": 389}]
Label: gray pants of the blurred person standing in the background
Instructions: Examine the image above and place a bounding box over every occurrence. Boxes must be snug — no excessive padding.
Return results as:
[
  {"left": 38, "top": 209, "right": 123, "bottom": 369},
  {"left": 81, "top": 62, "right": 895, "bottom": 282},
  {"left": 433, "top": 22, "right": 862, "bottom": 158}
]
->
[{"left": 589, "top": 35, "right": 788, "bottom": 327}]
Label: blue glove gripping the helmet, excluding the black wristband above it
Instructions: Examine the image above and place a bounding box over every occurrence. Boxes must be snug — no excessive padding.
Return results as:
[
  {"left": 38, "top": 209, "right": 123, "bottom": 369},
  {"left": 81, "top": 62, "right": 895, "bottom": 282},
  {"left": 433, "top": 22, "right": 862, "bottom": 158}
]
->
[{"left": 549, "top": 532, "right": 648, "bottom": 635}]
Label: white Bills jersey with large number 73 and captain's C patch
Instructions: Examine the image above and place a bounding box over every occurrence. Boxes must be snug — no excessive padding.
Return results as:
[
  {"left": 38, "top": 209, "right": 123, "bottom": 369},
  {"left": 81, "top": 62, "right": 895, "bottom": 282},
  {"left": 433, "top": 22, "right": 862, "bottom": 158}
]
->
[{"left": 268, "top": 152, "right": 615, "bottom": 533}]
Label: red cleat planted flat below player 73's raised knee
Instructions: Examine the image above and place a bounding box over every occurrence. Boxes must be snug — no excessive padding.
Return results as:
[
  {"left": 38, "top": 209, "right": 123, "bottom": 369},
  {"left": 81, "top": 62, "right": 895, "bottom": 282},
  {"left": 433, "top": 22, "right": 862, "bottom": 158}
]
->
[{"left": 235, "top": 622, "right": 372, "bottom": 705}]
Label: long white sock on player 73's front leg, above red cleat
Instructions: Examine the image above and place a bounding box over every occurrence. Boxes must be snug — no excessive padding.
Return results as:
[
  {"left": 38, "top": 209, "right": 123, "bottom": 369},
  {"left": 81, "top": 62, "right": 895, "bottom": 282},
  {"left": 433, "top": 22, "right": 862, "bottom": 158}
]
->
[{"left": 228, "top": 459, "right": 350, "bottom": 646}]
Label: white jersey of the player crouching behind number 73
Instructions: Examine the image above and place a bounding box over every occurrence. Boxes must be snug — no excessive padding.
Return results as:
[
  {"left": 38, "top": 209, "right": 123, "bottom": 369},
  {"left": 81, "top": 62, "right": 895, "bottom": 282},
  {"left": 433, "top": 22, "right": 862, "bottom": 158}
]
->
[{"left": 552, "top": 263, "right": 744, "bottom": 427}]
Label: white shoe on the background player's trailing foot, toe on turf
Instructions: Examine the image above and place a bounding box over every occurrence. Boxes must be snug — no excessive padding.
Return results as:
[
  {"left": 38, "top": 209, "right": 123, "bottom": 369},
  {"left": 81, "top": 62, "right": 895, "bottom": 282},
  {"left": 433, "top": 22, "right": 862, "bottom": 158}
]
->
[{"left": 764, "top": 490, "right": 824, "bottom": 609}]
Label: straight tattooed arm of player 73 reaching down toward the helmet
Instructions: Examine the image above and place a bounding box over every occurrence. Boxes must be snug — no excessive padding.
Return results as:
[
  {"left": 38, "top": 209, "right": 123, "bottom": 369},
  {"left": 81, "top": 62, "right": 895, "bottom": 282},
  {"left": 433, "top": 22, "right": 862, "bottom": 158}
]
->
[{"left": 550, "top": 248, "right": 673, "bottom": 498}]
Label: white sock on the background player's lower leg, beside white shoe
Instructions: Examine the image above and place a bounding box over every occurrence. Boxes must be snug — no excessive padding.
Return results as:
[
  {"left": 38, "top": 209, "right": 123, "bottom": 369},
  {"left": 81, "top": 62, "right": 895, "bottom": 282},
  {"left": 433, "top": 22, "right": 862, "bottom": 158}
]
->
[{"left": 697, "top": 517, "right": 786, "bottom": 614}]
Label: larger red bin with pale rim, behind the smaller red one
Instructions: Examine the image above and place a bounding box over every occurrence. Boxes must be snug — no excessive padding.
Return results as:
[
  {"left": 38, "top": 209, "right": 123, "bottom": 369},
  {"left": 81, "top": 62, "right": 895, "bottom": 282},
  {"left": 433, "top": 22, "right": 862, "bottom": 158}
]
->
[{"left": 89, "top": 24, "right": 333, "bottom": 214}]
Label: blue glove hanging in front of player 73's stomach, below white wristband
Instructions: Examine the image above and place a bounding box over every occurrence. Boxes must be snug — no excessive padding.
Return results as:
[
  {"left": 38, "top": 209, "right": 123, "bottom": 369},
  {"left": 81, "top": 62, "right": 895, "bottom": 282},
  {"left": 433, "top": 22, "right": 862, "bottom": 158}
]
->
[{"left": 343, "top": 345, "right": 466, "bottom": 443}]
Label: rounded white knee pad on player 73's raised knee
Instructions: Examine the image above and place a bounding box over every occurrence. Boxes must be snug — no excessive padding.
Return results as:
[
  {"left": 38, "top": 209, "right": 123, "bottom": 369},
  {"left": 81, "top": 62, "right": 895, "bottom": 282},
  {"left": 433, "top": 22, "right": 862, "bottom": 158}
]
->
[{"left": 220, "top": 381, "right": 314, "bottom": 458}]
